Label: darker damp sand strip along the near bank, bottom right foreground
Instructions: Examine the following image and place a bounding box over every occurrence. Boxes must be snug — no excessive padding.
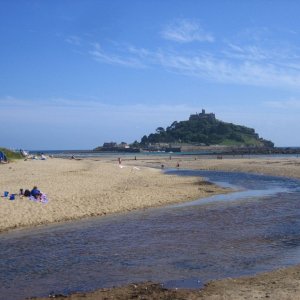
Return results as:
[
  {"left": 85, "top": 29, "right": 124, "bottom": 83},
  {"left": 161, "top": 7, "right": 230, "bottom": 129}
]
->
[{"left": 40, "top": 267, "right": 300, "bottom": 300}]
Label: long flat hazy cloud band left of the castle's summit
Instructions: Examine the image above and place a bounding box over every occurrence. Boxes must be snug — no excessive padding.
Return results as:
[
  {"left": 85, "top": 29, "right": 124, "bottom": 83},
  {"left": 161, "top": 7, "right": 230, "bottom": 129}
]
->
[{"left": 0, "top": 98, "right": 199, "bottom": 126}]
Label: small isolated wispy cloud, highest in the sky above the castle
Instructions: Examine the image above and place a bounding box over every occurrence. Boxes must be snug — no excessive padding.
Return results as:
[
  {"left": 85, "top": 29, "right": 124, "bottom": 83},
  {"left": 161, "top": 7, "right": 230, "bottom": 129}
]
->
[{"left": 161, "top": 19, "right": 214, "bottom": 43}]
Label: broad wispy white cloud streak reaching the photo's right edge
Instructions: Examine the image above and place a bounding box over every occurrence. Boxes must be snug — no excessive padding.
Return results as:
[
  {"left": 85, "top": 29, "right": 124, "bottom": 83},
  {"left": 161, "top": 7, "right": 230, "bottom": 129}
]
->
[{"left": 152, "top": 52, "right": 300, "bottom": 89}]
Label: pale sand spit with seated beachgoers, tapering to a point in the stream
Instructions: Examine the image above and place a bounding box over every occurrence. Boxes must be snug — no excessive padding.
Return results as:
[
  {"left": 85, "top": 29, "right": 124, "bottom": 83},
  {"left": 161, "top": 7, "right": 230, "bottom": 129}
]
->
[{"left": 0, "top": 159, "right": 226, "bottom": 231}]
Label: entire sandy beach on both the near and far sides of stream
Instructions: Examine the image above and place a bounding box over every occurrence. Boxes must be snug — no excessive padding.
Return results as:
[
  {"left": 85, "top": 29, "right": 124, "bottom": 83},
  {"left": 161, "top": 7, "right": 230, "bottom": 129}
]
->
[{"left": 0, "top": 156, "right": 300, "bottom": 300}]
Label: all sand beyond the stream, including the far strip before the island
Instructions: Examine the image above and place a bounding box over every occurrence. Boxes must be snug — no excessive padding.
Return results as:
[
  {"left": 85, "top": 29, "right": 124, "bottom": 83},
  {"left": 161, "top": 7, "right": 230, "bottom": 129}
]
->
[{"left": 0, "top": 155, "right": 300, "bottom": 231}]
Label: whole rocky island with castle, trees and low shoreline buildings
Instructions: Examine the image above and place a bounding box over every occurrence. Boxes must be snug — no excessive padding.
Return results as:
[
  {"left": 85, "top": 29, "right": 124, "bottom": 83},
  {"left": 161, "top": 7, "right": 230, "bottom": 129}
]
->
[{"left": 94, "top": 109, "right": 274, "bottom": 152}]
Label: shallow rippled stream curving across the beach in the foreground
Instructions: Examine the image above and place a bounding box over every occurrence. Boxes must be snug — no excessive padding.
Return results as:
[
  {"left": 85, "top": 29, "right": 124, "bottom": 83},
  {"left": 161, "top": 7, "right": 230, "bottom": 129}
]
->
[{"left": 0, "top": 171, "right": 300, "bottom": 300}]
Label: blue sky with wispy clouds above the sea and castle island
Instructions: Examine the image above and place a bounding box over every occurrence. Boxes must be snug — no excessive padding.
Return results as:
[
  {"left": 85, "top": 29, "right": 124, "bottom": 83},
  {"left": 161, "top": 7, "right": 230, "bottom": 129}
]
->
[{"left": 0, "top": 0, "right": 300, "bottom": 150}]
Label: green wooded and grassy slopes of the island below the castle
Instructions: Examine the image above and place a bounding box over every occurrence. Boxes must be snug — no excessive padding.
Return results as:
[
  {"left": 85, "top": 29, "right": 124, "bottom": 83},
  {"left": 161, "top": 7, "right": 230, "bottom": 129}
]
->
[{"left": 140, "top": 114, "right": 274, "bottom": 147}]
